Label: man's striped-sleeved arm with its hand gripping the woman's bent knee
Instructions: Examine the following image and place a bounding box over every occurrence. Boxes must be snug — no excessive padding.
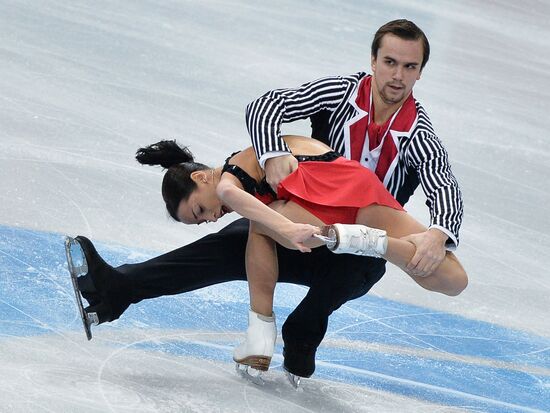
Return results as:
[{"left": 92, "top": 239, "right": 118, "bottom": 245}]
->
[{"left": 405, "top": 131, "right": 463, "bottom": 276}]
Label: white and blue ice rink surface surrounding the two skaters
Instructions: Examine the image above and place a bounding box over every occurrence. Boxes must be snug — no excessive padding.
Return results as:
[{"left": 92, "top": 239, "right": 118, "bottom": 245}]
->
[{"left": 0, "top": 0, "right": 550, "bottom": 413}]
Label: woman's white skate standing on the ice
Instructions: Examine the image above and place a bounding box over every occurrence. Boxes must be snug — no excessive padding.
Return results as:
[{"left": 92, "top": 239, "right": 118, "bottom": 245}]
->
[{"left": 233, "top": 310, "right": 277, "bottom": 384}]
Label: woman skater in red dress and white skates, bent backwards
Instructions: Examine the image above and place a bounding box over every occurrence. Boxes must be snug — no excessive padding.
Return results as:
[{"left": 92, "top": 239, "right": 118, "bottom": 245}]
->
[{"left": 136, "top": 136, "right": 468, "bottom": 371}]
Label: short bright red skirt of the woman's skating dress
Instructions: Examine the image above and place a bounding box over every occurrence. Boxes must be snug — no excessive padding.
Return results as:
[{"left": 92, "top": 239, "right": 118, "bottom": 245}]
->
[{"left": 277, "top": 156, "right": 403, "bottom": 225}]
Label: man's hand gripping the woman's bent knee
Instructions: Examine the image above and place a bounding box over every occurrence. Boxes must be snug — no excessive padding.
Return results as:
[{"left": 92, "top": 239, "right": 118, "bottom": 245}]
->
[{"left": 401, "top": 228, "right": 448, "bottom": 277}]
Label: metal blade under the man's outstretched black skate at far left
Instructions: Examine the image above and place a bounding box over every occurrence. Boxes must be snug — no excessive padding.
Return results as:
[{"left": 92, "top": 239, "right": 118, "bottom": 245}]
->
[{"left": 65, "top": 237, "right": 99, "bottom": 340}]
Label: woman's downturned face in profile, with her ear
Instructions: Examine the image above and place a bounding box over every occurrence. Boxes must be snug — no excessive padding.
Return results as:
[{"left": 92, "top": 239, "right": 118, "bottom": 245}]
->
[{"left": 177, "top": 170, "right": 228, "bottom": 225}]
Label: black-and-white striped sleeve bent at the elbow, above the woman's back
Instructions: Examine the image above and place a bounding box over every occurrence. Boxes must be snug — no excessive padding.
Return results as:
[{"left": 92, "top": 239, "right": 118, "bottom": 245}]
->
[{"left": 246, "top": 76, "right": 349, "bottom": 165}]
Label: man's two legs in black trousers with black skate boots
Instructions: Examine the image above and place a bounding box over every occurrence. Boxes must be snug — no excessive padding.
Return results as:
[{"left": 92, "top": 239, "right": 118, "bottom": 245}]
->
[{"left": 79, "top": 219, "right": 384, "bottom": 377}]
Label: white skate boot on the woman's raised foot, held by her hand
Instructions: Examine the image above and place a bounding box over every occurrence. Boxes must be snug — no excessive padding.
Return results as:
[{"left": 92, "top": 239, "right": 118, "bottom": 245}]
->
[{"left": 316, "top": 224, "right": 388, "bottom": 258}]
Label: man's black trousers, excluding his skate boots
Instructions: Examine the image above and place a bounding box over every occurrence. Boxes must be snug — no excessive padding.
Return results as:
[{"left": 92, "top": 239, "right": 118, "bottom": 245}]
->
[{"left": 116, "top": 219, "right": 385, "bottom": 348}]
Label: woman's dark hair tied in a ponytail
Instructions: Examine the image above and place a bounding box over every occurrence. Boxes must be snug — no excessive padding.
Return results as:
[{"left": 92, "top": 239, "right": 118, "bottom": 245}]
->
[{"left": 136, "top": 140, "right": 209, "bottom": 221}]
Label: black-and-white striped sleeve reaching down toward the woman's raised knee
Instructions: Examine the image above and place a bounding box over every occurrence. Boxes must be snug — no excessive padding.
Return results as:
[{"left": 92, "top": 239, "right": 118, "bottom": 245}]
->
[{"left": 406, "top": 129, "right": 463, "bottom": 249}]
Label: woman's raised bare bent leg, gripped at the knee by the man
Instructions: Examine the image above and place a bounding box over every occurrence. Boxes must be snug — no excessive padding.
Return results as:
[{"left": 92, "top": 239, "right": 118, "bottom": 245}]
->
[{"left": 356, "top": 205, "right": 468, "bottom": 295}]
